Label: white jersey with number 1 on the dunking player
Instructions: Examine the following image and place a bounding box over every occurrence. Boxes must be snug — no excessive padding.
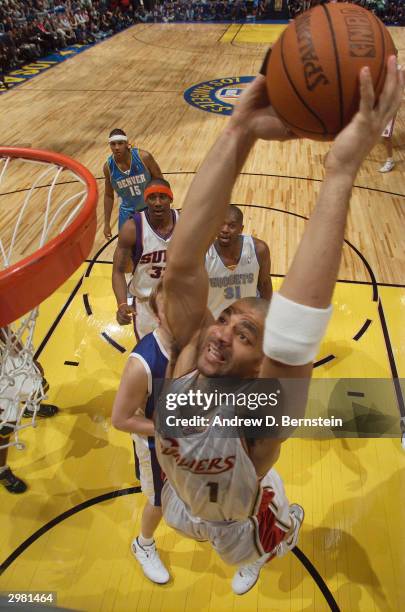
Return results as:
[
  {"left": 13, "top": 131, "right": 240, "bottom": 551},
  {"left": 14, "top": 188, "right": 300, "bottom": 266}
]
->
[{"left": 155, "top": 372, "right": 261, "bottom": 521}]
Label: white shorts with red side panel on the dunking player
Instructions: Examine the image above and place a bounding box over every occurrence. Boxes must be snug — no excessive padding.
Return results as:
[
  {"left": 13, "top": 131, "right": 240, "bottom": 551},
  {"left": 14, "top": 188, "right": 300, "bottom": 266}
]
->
[{"left": 162, "top": 470, "right": 291, "bottom": 565}]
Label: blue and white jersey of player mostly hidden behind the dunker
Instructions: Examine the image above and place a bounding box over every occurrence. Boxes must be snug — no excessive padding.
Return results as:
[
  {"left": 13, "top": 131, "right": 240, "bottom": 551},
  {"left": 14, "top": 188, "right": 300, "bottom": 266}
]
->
[{"left": 131, "top": 330, "right": 169, "bottom": 426}]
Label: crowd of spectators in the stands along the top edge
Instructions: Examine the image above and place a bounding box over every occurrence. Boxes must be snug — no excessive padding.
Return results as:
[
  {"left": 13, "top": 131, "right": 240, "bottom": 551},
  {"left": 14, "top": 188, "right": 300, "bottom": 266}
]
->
[{"left": 0, "top": 0, "right": 405, "bottom": 83}]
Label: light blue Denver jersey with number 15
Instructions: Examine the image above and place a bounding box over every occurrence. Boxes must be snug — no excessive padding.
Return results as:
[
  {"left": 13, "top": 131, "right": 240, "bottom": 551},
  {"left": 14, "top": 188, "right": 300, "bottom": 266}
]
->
[{"left": 107, "top": 148, "right": 151, "bottom": 218}]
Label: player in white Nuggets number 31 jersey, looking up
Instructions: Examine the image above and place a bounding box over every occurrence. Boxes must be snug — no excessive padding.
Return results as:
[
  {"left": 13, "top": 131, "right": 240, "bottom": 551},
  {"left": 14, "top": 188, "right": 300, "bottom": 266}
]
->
[{"left": 205, "top": 204, "right": 273, "bottom": 318}]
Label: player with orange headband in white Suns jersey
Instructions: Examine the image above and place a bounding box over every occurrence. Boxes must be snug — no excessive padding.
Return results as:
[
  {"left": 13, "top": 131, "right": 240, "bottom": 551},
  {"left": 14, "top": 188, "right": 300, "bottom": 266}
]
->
[{"left": 112, "top": 179, "right": 178, "bottom": 340}]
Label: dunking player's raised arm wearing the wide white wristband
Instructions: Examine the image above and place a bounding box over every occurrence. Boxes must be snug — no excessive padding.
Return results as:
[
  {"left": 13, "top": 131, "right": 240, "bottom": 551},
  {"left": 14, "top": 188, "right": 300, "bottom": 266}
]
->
[{"left": 261, "top": 56, "right": 404, "bottom": 378}]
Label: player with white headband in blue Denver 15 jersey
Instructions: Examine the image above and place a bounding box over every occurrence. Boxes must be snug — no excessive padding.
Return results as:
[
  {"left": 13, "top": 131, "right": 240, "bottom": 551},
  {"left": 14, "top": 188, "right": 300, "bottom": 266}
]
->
[{"left": 103, "top": 128, "right": 163, "bottom": 240}]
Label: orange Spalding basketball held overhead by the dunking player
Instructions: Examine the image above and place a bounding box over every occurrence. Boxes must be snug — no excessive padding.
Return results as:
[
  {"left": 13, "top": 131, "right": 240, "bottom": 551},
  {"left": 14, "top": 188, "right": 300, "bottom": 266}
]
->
[{"left": 267, "top": 3, "right": 395, "bottom": 140}]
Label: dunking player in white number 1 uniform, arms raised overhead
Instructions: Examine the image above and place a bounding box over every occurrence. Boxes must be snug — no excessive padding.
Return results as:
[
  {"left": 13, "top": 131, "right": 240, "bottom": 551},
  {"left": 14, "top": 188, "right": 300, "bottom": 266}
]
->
[{"left": 156, "top": 56, "right": 404, "bottom": 594}]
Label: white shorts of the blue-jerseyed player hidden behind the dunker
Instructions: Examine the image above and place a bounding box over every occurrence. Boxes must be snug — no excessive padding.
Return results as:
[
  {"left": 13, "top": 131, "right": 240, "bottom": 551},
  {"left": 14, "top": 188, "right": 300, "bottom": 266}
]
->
[{"left": 131, "top": 434, "right": 163, "bottom": 507}]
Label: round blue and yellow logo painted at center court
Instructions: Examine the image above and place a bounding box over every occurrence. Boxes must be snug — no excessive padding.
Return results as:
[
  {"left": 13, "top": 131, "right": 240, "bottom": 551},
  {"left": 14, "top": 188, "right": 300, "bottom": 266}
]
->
[{"left": 184, "top": 76, "right": 254, "bottom": 115}]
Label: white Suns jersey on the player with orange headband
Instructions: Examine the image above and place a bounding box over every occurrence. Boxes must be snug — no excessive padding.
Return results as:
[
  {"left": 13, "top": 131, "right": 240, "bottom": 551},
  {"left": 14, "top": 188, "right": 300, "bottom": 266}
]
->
[{"left": 129, "top": 209, "right": 178, "bottom": 299}]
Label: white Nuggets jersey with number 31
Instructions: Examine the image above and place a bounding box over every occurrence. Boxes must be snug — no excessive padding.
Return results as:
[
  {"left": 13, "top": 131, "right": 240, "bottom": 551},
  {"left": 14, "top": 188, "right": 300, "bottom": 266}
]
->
[{"left": 205, "top": 236, "right": 260, "bottom": 318}]
